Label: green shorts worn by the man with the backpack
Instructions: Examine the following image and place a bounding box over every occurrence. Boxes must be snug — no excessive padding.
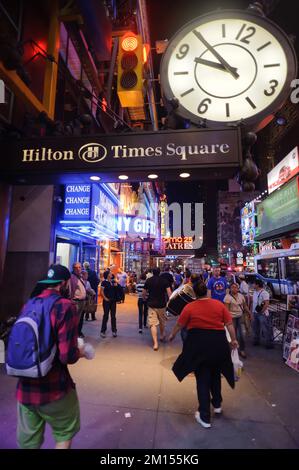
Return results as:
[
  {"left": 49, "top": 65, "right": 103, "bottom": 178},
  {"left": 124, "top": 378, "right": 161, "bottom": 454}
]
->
[{"left": 17, "top": 390, "right": 80, "bottom": 449}]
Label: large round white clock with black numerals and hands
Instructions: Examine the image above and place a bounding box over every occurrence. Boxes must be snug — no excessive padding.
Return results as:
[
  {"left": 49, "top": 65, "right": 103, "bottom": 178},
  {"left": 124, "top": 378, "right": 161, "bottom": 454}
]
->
[{"left": 160, "top": 10, "right": 297, "bottom": 127}]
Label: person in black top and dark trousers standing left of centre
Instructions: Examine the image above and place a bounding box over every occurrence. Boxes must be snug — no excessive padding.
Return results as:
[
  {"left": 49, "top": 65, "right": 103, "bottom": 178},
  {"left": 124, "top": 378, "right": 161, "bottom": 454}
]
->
[{"left": 101, "top": 271, "right": 117, "bottom": 338}]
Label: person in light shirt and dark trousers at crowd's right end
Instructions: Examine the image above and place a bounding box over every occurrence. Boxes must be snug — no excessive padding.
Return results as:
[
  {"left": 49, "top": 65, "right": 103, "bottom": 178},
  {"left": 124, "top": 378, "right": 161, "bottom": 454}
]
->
[{"left": 252, "top": 279, "right": 274, "bottom": 349}]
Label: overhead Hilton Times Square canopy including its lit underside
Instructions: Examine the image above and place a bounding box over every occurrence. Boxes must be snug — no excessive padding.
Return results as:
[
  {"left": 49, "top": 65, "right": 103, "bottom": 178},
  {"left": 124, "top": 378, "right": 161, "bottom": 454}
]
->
[{"left": 0, "top": 128, "right": 242, "bottom": 184}]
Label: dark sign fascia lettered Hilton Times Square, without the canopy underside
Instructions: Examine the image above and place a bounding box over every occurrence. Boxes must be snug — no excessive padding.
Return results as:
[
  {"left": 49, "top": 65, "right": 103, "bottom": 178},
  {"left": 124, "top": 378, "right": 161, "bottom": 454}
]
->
[{"left": 0, "top": 128, "right": 242, "bottom": 175}]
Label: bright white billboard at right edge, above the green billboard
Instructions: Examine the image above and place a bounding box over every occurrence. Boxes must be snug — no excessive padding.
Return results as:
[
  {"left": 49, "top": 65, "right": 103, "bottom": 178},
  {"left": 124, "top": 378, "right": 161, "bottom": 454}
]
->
[{"left": 267, "top": 147, "right": 299, "bottom": 194}]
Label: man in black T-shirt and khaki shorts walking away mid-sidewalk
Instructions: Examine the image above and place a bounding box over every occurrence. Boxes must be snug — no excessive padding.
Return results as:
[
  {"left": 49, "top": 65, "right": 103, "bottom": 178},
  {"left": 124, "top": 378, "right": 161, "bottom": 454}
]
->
[{"left": 142, "top": 268, "right": 171, "bottom": 351}]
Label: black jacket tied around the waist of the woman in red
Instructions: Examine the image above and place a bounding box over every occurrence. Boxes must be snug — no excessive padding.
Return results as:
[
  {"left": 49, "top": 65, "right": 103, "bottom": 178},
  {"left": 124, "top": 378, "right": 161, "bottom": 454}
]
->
[{"left": 172, "top": 328, "right": 235, "bottom": 388}]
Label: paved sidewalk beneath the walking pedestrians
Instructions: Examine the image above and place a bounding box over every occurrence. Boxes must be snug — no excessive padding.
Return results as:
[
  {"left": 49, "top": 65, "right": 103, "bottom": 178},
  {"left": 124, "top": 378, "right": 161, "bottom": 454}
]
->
[{"left": 0, "top": 295, "right": 299, "bottom": 449}]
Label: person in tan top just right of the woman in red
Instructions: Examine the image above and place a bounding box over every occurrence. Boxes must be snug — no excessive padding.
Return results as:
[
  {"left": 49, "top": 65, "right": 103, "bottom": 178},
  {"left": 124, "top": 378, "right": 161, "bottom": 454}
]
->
[{"left": 224, "top": 282, "right": 250, "bottom": 358}]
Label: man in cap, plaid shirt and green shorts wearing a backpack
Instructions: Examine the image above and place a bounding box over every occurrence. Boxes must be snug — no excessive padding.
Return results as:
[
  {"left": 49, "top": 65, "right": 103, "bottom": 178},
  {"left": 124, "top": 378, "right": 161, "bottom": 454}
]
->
[{"left": 6, "top": 265, "right": 84, "bottom": 449}]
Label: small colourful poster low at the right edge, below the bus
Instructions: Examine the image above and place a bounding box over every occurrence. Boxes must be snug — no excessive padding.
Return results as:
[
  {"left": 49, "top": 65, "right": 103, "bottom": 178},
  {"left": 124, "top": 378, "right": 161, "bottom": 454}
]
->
[{"left": 283, "top": 315, "right": 299, "bottom": 372}]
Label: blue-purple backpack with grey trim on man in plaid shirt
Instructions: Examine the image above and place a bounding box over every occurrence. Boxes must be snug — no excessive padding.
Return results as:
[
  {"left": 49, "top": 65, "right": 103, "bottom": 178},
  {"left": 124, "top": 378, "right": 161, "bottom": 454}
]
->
[{"left": 6, "top": 293, "right": 61, "bottom": 378}]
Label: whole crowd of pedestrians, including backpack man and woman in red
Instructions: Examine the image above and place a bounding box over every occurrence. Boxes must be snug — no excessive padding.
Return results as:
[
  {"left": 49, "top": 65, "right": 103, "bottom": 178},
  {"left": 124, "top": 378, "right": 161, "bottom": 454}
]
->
[{"left": 7, "top": 262, "right": 273, "bottom": 449}]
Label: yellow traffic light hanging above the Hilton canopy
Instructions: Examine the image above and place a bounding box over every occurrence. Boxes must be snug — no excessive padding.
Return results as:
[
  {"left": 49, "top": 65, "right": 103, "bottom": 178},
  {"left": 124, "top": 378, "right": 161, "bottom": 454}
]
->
[{"left": 117, "top": 32, "right": 144, "bottom": 108}]
